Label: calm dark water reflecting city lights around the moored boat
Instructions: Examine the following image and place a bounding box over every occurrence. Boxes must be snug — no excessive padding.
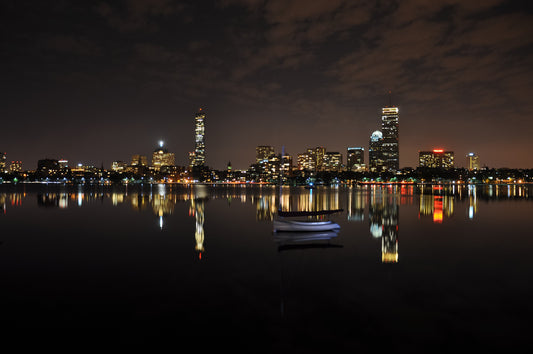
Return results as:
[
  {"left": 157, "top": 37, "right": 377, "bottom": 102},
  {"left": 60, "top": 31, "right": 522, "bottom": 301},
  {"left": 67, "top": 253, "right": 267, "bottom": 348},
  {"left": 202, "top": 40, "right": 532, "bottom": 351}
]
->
[{"left": 0, "top": 185, "right": 533, "bottom": 353}]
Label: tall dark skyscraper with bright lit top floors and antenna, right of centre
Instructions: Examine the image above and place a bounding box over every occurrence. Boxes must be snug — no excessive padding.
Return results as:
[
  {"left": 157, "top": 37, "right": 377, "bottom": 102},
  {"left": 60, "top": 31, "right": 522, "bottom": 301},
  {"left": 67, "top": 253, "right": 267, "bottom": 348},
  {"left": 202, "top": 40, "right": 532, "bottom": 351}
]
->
[{"left": 381, "top": 107, "right": 400, "bottom": 172}]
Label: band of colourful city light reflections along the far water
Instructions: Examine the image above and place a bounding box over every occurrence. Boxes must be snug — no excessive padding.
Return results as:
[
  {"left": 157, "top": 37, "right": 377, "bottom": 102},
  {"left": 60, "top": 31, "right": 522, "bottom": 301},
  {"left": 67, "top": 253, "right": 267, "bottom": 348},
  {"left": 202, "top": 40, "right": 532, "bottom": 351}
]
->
[{"left": 0, "top": 185, "right": 531, "bottom": 263}]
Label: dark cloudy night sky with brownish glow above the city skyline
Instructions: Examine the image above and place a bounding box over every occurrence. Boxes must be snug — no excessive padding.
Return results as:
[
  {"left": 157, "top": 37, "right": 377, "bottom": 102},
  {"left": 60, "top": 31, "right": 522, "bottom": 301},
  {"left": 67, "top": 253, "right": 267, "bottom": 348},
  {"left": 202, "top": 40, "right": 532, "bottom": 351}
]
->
[{"left": 0, "top": 0, "right": 533, "bottom": 169}]
